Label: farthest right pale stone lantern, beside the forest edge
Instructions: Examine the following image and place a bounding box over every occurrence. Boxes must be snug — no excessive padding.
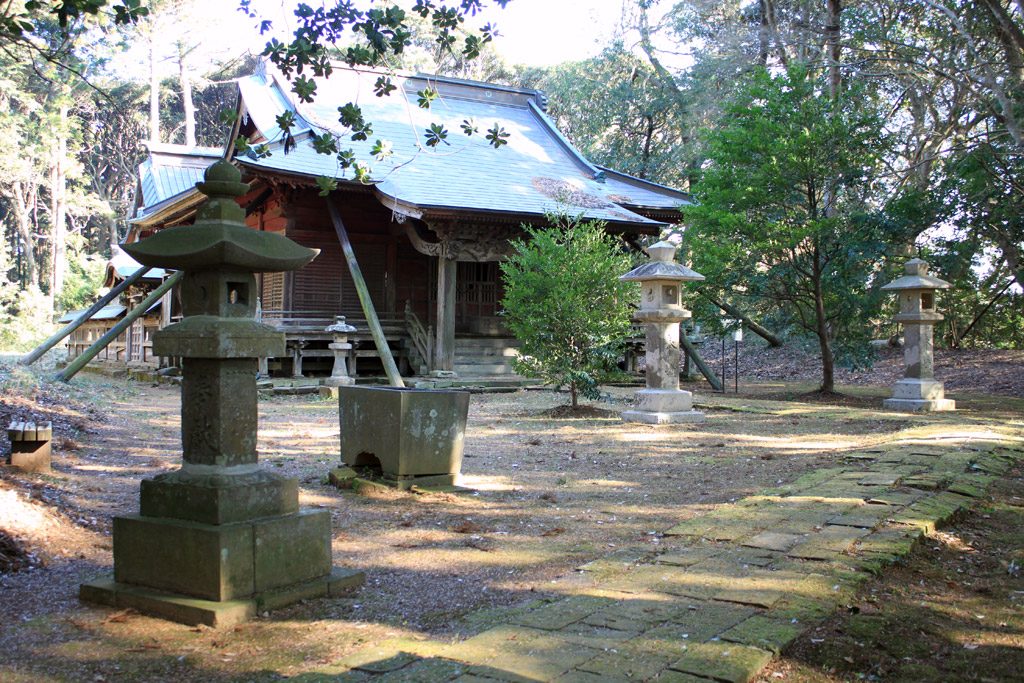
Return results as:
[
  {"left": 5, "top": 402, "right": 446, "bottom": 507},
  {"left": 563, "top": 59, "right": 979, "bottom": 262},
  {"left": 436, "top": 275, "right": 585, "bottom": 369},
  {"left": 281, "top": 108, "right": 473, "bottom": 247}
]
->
[{"left": 882, "top": 258, "right": 956, "bottom": 412}]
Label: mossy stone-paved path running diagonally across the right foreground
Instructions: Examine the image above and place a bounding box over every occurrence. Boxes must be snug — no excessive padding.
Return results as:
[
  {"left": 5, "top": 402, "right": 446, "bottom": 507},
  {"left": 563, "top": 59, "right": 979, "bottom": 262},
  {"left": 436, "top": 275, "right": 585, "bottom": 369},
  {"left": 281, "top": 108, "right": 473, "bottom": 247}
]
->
[{"left": 299, "top": 423, "right": 1024, "bottom": 683}]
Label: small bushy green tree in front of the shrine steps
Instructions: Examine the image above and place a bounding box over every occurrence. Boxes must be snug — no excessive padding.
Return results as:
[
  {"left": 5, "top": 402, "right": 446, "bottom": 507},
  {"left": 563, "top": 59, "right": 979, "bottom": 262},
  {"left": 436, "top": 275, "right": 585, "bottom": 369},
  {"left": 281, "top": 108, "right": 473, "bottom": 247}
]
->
[{"left": 502, "top": 217, "right": 637, "bottom": 408}]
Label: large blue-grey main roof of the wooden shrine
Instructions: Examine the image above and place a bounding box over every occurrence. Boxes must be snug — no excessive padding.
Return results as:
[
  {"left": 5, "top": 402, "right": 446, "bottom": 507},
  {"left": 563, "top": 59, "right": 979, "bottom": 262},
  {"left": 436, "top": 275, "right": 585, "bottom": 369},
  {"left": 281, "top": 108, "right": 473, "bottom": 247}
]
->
[{"left": 239, "top": 68, "right": 686, "bottom": 225}]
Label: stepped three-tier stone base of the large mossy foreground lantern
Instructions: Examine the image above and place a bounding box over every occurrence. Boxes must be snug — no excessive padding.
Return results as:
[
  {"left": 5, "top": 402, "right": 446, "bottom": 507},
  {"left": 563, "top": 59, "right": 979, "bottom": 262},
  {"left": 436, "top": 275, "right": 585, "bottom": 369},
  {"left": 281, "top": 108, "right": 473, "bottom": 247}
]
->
[{"left": 79, "top": 473, "right": 364, "bottom": 628}]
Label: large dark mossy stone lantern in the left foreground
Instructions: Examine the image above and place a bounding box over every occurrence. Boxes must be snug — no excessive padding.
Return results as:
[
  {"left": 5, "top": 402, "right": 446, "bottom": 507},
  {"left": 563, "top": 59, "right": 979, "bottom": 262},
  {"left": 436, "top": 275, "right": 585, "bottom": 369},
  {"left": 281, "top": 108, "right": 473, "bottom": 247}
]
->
[{"left": 80, "top": 161, "right": 362, "bottom": 627}]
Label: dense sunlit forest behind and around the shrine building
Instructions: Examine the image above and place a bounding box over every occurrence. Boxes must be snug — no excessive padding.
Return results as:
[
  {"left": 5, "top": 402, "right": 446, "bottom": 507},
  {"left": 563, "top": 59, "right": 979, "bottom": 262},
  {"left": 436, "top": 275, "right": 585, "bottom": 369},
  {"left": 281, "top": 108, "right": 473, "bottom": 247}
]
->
[{"left": 0, "top": 0, "right": 1024, "bottom": 362}]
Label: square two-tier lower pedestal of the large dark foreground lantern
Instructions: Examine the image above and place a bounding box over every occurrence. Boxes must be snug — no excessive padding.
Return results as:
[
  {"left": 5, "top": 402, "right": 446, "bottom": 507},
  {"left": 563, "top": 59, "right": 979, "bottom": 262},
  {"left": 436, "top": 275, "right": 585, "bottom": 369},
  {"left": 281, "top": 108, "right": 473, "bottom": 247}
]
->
[{"left": 79, "top": 510, "right": 364, "bottom": 627}]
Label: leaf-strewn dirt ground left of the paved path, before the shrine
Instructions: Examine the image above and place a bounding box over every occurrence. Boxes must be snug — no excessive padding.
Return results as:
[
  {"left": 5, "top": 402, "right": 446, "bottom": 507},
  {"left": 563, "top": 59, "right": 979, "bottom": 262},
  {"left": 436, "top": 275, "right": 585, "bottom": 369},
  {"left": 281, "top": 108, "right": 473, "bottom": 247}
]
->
[{"left": 0, "top": 360, "right": 1024, "bottom": 681}]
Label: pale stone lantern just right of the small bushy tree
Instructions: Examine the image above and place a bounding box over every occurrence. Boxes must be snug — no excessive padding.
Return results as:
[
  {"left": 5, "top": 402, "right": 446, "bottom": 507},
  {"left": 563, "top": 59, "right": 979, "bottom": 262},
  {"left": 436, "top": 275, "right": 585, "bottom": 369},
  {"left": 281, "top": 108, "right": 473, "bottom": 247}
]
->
[{"left": 620, "top": 242, "right": 705, "bottom": 425}]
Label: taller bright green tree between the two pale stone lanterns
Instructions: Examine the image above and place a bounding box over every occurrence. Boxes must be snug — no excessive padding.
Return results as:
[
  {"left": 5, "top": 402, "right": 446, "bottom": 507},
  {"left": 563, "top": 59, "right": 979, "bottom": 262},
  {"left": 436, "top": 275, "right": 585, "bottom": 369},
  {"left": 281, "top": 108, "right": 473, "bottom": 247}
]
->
[{"left": 684, "top": 68, "right": 903, "bottom": 391}]
